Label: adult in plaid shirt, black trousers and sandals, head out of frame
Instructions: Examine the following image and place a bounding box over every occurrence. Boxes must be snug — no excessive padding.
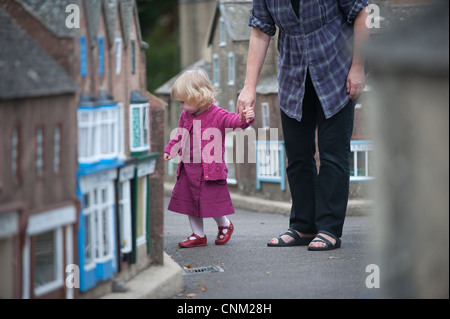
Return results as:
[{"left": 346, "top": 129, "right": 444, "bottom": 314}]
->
[{"left": 236, "top": 0, "right": 369, "bottom": 250}]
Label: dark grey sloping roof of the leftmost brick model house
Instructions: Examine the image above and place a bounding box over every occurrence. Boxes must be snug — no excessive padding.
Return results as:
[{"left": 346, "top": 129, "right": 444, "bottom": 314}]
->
[{"left": 0, "top": 7, "right": 78, "bottom": 99}]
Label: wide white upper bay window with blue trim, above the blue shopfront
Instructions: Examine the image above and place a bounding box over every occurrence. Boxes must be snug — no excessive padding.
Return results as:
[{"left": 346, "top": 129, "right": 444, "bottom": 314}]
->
[{"left": 78, "top": 105, "right": 120, "bottom": 164}]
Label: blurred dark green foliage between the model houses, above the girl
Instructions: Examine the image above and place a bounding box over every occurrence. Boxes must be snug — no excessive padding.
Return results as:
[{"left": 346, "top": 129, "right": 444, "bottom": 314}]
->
[{"left": 136, "top": 0, "right": 180, "bottom": 93}]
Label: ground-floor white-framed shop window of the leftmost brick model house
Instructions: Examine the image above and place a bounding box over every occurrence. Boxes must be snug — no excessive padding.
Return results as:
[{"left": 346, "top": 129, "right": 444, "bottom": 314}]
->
[{"left": 33, "top": 228, "right": 63, "bottom": 296}]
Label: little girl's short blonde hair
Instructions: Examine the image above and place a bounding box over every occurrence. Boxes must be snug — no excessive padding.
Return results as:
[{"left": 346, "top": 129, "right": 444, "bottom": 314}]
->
[{"left": 171, "top": 69, "right": 216, "bottom": 107}]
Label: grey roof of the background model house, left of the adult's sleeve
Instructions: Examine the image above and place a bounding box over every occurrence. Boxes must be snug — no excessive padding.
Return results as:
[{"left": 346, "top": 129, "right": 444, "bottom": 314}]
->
[{"left": 208, "top": 0, "right": 252, "bottom": 46}]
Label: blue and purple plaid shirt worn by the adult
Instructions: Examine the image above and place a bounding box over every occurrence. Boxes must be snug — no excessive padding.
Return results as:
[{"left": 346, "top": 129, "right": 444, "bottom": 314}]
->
[{"left": 248, "top": 0, "right": 368, "bottom": 121}]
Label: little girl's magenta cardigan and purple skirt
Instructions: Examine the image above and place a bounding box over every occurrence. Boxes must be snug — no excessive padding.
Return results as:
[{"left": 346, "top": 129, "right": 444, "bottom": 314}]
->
[{"left": 164, "top": 104, "right": 254, "bottom": 218}]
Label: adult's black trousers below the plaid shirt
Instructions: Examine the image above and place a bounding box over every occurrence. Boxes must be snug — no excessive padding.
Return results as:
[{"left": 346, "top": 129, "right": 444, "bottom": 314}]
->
[{"left": 281, "top": 74, "right": 355, "bottom": 237}]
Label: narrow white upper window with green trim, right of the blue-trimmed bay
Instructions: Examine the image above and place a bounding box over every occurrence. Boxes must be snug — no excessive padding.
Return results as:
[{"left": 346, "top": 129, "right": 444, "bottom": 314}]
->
[{"left": 130, "top": 103, "right": 150, "bottom": 152}]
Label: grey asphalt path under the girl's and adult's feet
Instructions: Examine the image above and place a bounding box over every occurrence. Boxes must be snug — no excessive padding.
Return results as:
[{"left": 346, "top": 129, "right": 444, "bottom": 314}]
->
[{"left": 164, "top": 197, "right": 377, "bottom": 299}]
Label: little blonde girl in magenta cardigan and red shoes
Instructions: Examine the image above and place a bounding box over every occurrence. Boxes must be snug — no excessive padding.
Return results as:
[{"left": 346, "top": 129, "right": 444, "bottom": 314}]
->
[{"left": 164, "top": 69, "right": 254, "bottom": 247}]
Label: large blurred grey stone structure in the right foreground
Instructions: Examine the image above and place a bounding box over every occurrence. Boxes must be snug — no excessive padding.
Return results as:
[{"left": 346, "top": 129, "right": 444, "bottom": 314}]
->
[{"left": 368, "top": 1, "right": 449, "bottom": 298}]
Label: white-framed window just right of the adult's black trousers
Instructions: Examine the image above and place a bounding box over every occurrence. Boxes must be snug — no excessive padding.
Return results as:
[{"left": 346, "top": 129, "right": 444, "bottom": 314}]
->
[{"left": 350, "top": 140, "right": 374, "bottom": 182}]
